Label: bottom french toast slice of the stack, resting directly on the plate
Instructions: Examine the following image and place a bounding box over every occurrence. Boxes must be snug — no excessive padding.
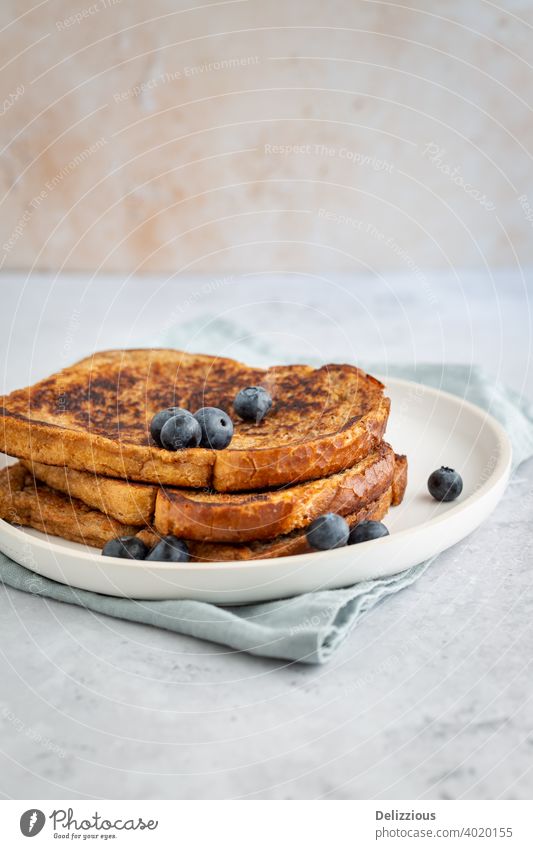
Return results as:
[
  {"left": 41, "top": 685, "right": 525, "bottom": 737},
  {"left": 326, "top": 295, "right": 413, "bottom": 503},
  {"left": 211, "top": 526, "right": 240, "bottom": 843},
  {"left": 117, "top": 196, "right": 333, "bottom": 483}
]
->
[{"left": 0, "top": 456, "right": 407, "bottom": 562}]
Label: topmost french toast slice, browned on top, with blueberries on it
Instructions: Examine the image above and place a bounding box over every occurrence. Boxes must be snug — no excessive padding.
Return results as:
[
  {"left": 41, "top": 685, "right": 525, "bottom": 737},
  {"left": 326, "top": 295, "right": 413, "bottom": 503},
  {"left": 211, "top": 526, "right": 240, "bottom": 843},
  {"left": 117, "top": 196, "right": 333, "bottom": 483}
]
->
[{"left": 0, "top": 349, "right": 390, "bottom": 492}]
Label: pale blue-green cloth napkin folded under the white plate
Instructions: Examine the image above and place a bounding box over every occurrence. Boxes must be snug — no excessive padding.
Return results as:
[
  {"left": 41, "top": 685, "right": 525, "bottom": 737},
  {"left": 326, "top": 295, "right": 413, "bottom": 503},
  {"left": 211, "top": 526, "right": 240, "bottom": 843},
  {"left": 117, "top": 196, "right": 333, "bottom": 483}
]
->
[{"left": 0, "top": 364, "right": 533, "bottom": 663}]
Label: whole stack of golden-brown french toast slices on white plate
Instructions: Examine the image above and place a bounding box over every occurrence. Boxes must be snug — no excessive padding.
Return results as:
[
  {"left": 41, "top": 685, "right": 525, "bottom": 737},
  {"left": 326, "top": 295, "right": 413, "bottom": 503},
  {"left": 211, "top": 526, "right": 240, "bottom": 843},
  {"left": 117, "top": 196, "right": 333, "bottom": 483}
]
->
[{"left": 0, "top": 349, "right": 407, "bottom": 561}]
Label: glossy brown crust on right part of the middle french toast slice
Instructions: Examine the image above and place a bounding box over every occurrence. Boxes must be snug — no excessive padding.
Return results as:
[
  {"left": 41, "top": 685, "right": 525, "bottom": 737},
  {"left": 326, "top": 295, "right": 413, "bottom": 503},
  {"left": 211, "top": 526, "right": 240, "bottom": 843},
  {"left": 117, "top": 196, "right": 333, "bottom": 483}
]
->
[{"left": 154, "top": 442, "right": 395, "bottom": 543}]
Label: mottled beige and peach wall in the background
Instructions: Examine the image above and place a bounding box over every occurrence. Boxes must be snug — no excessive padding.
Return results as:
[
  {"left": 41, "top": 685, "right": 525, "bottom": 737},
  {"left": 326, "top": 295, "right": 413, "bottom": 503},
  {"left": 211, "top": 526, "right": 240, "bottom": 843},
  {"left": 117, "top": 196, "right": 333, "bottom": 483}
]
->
[{"left": 0, "top": 0, "right": 533, "bottom": 275}]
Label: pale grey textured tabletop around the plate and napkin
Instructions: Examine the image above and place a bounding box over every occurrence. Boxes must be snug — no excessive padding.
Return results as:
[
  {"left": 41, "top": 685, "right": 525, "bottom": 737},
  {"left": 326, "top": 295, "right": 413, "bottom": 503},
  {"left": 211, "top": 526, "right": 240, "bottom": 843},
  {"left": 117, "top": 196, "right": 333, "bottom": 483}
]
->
[{"left": 0, "top": 272, "right": 533, "bottom": 798}]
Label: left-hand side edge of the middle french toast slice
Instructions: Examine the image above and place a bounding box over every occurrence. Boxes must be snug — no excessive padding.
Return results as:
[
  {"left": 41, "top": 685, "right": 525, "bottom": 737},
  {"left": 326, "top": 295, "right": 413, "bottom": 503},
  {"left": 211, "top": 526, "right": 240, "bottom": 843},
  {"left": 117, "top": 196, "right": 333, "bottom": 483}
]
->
[{"left": 23, "top": 460, "right": 157, "bottom": 527}]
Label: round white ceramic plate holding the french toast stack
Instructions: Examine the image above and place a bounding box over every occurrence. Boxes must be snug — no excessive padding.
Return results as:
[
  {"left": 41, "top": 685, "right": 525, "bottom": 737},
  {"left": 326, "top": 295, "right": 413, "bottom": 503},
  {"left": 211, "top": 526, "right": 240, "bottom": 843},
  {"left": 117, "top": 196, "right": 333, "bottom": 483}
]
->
[{"left": 0, "top": 379, "right": 511, "bottom": 604}]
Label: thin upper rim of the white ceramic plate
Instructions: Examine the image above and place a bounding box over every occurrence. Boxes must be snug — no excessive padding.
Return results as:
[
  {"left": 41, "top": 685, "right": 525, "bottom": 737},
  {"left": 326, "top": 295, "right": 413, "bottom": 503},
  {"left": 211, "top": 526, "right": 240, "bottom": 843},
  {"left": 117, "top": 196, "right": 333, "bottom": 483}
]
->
[{"left": 0, "top": 376, "right": 513, "bottom": 572}]
